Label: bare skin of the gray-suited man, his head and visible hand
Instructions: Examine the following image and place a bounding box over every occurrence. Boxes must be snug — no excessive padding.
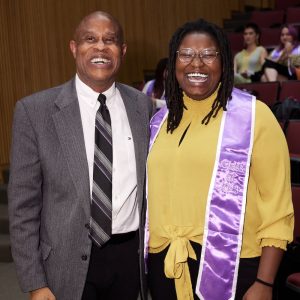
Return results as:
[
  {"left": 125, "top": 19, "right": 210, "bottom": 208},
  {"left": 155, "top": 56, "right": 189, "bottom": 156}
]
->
[{"left": 30, "top": 12, "right": 127, "bottom": 300}]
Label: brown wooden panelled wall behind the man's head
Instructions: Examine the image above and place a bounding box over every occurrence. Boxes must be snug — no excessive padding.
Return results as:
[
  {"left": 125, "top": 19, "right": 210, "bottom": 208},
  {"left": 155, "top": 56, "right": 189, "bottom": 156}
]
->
[{"left": 0, "top": 0, "right": 272, "bottom": 165}]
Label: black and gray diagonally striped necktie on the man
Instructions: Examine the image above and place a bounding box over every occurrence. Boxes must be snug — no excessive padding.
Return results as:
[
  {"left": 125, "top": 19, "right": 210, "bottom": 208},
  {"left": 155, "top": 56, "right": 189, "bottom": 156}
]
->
[{"left": 89, "top": 94, "right": 113, "bottom": 247}]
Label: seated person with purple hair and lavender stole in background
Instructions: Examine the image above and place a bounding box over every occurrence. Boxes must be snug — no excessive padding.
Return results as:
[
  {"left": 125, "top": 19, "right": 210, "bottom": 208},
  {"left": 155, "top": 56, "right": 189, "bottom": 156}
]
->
[{"left": 261, "top": 25, "right": 300, "bottom": 82}]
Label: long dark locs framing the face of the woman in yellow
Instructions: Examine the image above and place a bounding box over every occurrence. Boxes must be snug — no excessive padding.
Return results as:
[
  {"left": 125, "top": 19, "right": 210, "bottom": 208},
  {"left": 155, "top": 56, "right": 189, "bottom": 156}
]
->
[{"left": 166, "top": 19, "right": 234, "bottom": 133}]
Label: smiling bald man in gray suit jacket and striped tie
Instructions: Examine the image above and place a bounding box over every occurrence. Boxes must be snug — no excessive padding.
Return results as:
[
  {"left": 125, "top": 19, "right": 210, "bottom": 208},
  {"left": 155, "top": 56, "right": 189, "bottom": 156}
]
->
[{"left": 9, "top": 12, "right": 152, "bottom": 300}]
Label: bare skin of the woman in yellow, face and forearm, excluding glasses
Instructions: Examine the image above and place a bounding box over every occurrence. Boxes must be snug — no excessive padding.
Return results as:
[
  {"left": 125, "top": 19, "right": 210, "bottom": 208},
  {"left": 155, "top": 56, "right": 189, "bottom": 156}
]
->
[{"left": 176, "top": 32, "right": 284, "bottom": 300}]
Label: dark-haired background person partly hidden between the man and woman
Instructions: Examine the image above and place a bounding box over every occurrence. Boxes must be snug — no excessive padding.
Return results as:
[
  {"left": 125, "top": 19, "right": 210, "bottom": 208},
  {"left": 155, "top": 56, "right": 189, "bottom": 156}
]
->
[{"left": 143, "top": 57, "right": 168, "bottom": 109}]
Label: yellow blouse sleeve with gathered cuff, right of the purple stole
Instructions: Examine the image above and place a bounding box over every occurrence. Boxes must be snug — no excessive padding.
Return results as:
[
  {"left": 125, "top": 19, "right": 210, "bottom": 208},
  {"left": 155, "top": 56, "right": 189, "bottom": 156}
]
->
[{"left": 251, "top": 101, "right": 294, "bottom": 250}]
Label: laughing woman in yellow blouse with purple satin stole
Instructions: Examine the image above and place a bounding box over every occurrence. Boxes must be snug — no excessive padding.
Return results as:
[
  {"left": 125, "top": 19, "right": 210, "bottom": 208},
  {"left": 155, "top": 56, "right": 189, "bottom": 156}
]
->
[{"left": 145, "top": 19, "right": 293, "bottom": 300}]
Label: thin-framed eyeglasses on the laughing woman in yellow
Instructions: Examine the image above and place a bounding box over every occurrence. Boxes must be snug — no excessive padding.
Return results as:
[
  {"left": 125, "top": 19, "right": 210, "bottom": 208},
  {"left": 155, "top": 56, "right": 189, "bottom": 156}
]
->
[{"left": 176, "top": 48, "right": 219, "bottom": 65}]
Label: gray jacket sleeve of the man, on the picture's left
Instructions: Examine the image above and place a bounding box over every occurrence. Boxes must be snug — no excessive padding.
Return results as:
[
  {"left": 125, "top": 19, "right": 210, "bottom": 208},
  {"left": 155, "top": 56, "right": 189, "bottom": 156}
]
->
[{"left": 8, "top": 101, "right": 47, "bottom": 292}]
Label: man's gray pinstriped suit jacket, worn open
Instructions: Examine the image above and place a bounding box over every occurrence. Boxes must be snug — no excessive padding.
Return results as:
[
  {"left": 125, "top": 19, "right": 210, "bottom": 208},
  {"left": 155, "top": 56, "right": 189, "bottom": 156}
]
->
[{"left": 8, "top": 79, "right": 152, "bottom": 300}]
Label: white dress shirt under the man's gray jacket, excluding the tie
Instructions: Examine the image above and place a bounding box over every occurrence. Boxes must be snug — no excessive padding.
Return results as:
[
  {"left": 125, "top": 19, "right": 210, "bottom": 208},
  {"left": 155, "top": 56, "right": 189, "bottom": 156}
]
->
[{"left": 75, "top": 75, "right": 139, "bottom": 234}]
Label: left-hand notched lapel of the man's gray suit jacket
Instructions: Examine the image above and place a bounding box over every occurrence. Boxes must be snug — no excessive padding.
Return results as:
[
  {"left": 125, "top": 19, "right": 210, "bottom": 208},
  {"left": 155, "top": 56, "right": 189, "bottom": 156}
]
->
[{"left": 53, "top": 80, "right": 90, "bottom": 216}]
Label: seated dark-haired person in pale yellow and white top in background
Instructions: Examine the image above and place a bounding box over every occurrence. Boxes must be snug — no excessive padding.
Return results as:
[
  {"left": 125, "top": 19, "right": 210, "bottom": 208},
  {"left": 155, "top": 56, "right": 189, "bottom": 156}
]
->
[{"left": 234, "top": 23, "right": 268, "bottom": 84}]
